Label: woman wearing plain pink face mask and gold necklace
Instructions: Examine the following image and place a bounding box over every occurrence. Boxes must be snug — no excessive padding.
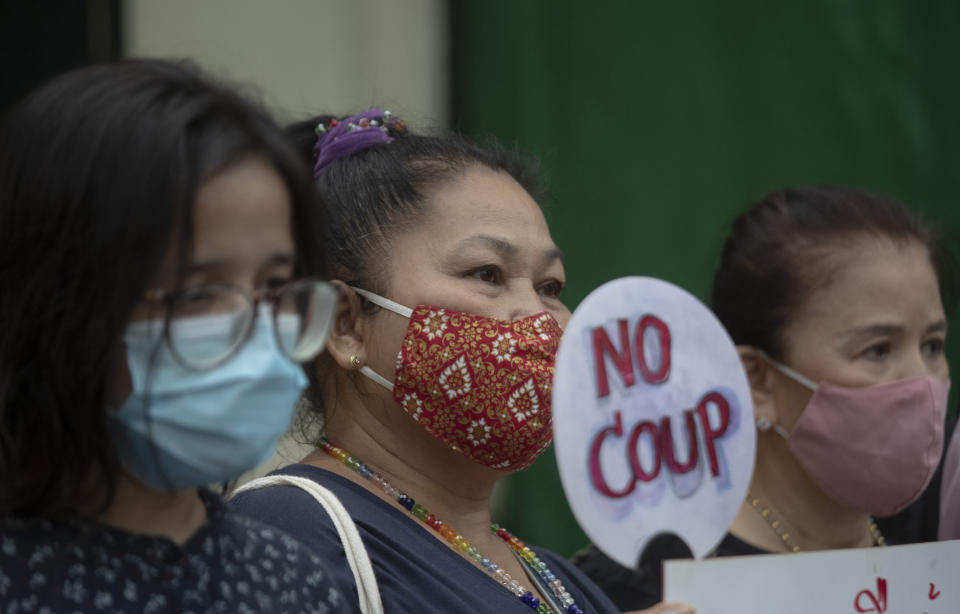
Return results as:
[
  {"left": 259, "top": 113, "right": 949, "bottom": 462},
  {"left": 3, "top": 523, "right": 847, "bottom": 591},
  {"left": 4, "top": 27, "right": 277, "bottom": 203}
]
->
[{"left": 579, "top": 186, "right": 950, "bottom": 607}]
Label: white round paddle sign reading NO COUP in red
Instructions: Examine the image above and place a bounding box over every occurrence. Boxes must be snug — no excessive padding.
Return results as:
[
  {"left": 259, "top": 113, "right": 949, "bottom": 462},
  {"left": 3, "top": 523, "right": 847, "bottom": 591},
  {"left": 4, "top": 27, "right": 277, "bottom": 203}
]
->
[{"left": 553, "top": 277, "right": 756, "bottom": 568}]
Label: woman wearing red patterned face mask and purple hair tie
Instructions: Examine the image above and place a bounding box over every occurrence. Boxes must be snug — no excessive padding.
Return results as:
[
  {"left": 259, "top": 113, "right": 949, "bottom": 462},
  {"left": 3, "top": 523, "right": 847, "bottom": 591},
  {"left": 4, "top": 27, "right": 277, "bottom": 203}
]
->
[{"left": 234, "top": 110, "right": 696, "bottom": 614}]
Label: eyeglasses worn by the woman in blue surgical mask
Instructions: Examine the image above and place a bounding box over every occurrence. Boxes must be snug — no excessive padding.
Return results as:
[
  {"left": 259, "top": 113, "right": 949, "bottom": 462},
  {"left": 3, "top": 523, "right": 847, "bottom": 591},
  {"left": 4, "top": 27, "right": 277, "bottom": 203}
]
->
[{"left": 145, "top": 279, "right": 339, "bottom": 371}]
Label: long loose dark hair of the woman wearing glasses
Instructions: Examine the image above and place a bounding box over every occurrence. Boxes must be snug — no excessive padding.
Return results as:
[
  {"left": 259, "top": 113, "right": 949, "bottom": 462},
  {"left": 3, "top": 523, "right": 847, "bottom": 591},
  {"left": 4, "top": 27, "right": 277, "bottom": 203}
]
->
[{"left": 0, "top": 60, "right": 323, "bottom": 514}]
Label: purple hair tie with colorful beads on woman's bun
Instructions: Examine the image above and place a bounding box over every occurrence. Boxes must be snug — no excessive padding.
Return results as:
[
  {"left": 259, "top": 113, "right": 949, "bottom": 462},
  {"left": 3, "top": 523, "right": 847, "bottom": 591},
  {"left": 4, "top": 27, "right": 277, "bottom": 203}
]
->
[{"left": 313, "top": 109, "right": 407, "bottom": 178}]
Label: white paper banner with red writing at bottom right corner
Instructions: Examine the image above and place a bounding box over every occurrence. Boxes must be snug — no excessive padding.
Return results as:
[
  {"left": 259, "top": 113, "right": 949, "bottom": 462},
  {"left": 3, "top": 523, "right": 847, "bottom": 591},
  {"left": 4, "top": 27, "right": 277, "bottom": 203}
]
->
[{"left": 664, "top": 541, "right": 960, "bottom": 614}]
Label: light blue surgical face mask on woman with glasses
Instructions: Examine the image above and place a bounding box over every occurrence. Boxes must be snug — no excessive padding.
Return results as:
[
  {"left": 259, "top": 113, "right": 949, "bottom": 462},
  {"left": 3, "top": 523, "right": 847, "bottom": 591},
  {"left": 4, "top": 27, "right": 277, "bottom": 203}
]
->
[{"left": 110, "top": 306, "right": 307, "bottom": 491}]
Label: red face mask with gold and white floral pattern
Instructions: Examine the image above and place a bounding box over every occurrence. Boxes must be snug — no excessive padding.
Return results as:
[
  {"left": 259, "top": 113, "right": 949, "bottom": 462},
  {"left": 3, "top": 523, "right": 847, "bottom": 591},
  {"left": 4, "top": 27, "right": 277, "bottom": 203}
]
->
[{"left": 354, "top": 288, "right": 563, "bottom": 471}]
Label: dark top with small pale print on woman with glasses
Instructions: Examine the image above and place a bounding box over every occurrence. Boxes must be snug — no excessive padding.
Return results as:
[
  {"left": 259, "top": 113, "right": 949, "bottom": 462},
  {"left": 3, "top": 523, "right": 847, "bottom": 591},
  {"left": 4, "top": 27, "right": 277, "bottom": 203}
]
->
[{"left": 0, "top": 490, "right": 343, "bottom": 614}]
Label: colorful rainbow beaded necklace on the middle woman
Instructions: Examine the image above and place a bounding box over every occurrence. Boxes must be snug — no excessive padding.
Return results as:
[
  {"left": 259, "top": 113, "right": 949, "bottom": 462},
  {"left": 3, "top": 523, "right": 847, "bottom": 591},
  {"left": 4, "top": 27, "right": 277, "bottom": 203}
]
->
[{"left": 321, "top": 438, "right": 583, "bottom": 614}]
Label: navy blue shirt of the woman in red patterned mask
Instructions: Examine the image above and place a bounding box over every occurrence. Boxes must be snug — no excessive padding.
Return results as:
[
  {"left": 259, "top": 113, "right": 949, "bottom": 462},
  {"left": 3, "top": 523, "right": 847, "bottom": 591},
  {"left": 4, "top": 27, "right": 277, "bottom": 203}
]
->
[{"left": 230, "top": 465, "right": 618, "bottom": 614}]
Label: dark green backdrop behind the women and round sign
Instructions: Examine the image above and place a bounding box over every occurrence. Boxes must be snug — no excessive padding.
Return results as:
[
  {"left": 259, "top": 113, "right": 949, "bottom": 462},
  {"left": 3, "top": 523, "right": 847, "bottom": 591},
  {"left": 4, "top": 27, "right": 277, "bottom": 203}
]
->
[{"left": 451, "top": 0, "right": 960, "bottom": 554}]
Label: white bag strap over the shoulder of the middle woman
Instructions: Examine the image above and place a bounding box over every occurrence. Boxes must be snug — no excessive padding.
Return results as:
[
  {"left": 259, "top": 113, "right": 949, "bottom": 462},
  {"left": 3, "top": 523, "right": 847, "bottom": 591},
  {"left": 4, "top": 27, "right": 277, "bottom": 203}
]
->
[{"left": 231, "top": 475, "right": 383, "bottom": 614}]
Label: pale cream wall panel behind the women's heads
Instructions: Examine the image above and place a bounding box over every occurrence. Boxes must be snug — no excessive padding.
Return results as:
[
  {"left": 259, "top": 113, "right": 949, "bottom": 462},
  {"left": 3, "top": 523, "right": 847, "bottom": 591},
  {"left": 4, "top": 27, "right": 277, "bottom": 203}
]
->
[{"left": 123, "top": 0, "right": 448, "bottom": 126}]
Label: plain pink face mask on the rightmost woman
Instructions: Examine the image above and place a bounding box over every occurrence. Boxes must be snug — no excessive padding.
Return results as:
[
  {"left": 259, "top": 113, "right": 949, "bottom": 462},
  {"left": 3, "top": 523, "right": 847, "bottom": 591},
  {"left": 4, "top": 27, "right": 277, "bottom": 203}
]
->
[{"left": 765, "top": 357, "right": 950, "bottom": 516}]
